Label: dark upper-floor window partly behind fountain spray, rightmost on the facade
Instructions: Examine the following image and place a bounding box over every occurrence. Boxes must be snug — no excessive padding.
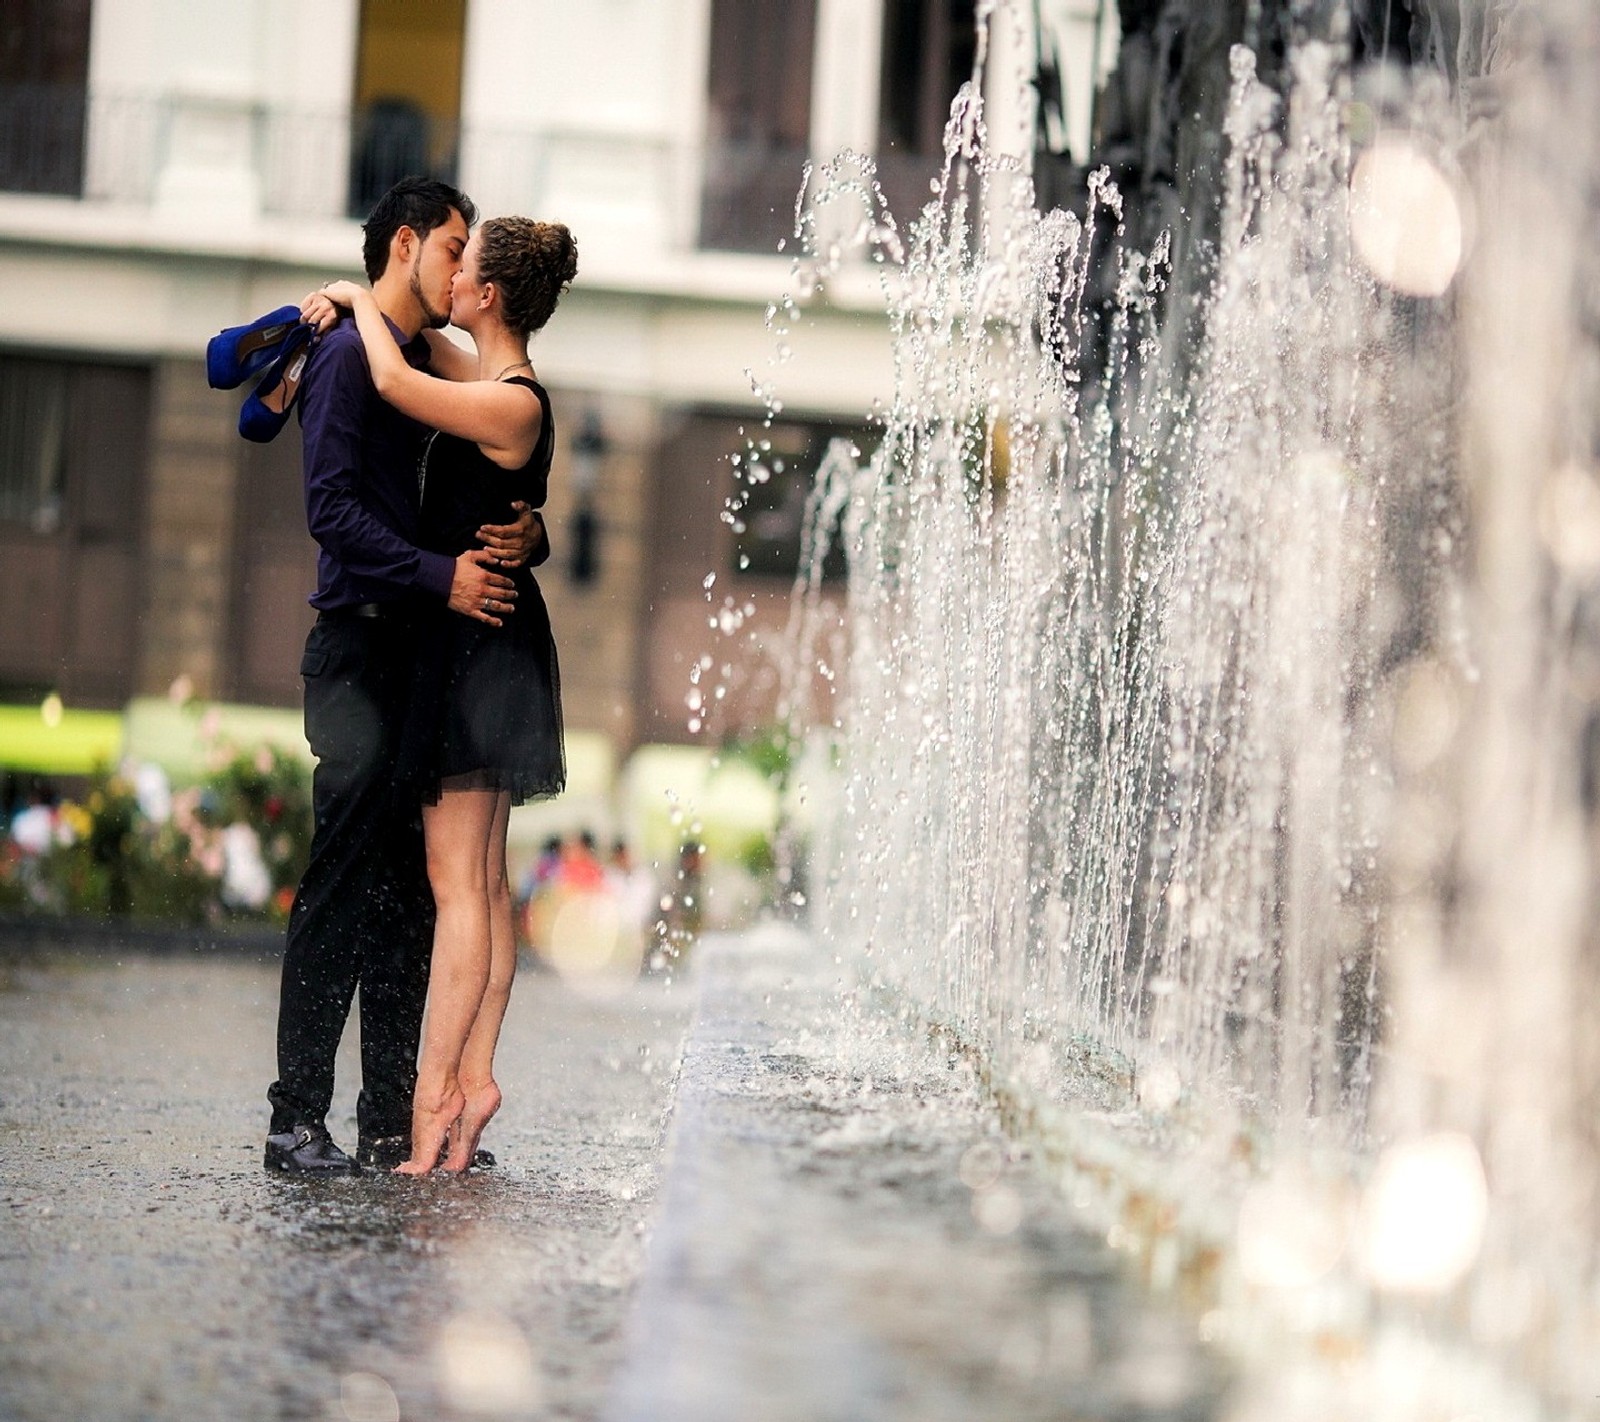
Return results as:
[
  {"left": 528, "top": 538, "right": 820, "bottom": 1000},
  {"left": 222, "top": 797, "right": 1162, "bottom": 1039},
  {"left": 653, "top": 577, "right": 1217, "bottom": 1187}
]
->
[{"left": 878, "top": 0, "right": 978, "bottom": 222}]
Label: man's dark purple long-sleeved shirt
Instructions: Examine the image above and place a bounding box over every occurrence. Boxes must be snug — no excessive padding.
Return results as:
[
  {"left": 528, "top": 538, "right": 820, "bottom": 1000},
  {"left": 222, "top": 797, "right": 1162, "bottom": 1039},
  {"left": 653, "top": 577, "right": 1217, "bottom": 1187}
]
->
[{"left": 299, "top": 322, "right": 456, "bottom": 611}]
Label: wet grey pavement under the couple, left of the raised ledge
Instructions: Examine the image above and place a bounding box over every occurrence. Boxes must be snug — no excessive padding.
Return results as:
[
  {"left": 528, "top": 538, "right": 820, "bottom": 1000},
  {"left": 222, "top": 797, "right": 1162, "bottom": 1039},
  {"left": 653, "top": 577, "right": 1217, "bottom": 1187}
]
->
[{"left": 0, "top": 955, "right": 686, "bottom": 1422}]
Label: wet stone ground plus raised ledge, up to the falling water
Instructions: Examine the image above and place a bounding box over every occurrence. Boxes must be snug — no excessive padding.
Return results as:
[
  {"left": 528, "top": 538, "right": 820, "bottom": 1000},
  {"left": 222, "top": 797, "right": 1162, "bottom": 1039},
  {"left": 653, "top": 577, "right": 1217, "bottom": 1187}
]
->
[{"left": 0, "top": 929, "right": 1224, "bottom": 1422}]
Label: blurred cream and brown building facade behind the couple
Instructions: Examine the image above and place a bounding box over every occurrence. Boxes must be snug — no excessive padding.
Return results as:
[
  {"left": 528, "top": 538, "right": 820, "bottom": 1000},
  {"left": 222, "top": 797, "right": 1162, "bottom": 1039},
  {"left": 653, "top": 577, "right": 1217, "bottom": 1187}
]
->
[{"left": 0, "top": 0, "right": 1110, "bottom": 750}]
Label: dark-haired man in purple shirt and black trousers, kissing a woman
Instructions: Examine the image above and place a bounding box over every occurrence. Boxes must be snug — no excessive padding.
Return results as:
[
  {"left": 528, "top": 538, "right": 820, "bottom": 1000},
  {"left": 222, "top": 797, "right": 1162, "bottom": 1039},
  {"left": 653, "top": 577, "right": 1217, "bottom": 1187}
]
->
[{"left": 266, "top": 178, "right": 549, "bottom": 1176}]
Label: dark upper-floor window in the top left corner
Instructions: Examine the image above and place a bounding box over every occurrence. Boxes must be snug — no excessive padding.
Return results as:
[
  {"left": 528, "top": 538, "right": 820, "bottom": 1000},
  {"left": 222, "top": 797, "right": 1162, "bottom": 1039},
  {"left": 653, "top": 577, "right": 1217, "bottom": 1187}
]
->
[{"left": 0, "top": 0, "right": 90, "bottom": 195}]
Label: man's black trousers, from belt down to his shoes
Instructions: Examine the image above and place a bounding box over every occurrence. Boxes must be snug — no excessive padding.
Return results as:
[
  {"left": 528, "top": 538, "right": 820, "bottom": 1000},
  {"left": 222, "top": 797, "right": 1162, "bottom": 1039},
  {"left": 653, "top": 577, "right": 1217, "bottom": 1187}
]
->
[{"left": 267, "top": 608, "right": 434, "bottom": 1137}]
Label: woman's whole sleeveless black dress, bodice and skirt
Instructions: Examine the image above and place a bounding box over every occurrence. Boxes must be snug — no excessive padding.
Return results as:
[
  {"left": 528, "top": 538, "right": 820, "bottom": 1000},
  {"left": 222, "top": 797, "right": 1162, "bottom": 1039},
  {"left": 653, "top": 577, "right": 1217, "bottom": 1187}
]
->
[{"left": 411, "top": 376, "right": 566, "bottom": 805}]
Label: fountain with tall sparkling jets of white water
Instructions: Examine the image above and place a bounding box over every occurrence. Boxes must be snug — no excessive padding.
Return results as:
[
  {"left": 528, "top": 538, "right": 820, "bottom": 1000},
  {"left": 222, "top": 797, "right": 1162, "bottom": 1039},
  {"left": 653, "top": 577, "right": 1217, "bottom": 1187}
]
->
[{"left": 734, "top": 0, "right": 1600, "bottom": 1419}]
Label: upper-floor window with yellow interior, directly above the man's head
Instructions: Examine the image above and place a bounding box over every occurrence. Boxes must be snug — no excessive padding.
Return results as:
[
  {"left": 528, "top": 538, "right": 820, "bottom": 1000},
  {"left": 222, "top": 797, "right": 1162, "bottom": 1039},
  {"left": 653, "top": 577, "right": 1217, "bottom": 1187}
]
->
[{"left": 349, "top": 0, "right": 467, "bottom": 218}]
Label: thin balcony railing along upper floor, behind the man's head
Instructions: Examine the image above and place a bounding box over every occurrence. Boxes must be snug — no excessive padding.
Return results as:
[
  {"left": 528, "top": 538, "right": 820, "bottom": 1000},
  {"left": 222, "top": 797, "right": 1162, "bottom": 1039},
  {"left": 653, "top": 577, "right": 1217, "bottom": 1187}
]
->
[{"left": 0, "top": 86, "right": 838, "bottom": 253}]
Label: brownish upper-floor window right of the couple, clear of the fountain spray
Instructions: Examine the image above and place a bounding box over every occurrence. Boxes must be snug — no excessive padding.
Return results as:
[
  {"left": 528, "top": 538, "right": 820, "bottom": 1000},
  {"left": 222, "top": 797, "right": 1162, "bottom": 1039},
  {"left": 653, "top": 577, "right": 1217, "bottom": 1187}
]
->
[{"left": 701, "top": 0, "right": 816, "bottom": 253}]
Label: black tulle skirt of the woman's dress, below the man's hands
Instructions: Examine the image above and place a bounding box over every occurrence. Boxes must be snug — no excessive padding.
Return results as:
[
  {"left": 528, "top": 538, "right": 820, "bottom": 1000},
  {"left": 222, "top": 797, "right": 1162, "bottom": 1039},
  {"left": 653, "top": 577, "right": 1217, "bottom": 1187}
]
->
[{"left": 403, "top": 576, "right": 566, "bottom": 805}]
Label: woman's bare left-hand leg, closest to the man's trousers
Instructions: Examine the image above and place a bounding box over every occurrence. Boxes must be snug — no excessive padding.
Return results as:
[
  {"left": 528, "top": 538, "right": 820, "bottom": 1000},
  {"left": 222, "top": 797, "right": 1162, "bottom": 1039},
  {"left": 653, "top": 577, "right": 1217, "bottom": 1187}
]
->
[{"left": 398, "top": 790, "right": 499, "bottom": 1176}]
